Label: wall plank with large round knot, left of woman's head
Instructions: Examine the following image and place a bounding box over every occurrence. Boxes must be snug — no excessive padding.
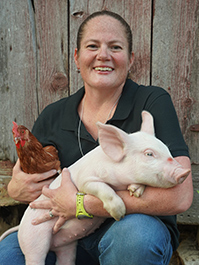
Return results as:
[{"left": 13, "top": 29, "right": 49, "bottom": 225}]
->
[{"left": 34, "top": 0, "right": 69, "bottom": 113}]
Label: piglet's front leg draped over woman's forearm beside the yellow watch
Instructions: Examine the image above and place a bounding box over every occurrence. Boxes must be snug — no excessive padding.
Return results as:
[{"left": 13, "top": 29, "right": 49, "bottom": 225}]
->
[{"left": 83, "top": 182, "right": 126, "bottom": 221}]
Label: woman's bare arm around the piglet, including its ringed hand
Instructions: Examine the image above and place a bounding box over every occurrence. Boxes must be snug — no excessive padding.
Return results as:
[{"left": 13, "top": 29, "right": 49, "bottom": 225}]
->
[{"left": 30, "top": 157, "right": 193, "bottom": 232}]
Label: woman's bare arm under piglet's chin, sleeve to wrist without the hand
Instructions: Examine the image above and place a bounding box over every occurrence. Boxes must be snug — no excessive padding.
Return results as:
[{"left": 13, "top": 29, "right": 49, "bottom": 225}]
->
[{"left": 84, "top": 156, "right": 193, "bottom": 217}]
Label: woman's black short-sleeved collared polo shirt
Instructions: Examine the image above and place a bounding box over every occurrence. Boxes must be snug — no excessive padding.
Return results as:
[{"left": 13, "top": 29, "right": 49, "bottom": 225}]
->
[{"left": 33, "top": 79, "right": 189, "bottom": 249}]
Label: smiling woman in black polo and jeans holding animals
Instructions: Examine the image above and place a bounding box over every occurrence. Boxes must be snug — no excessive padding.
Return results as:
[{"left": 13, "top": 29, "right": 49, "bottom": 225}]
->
[{"left": 0, "top": 11, "right": 193, "bottom": 265}]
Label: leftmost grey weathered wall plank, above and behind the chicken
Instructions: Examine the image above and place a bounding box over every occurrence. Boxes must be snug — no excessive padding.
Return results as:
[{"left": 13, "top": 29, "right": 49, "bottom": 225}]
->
[{"left": 0, "top": 0, "right": 38, "bottom": 161}]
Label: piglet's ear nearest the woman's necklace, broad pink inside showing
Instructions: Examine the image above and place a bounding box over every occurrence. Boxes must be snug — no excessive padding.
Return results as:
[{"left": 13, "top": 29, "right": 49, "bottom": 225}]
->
[{"left": 97, "top": 122, "right": 128, "bottom": 162}]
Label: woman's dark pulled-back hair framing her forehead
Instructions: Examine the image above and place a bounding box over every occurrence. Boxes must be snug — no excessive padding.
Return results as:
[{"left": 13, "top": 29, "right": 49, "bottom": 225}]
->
[{"left": 77, "top": 10, "right": 133, "bottom": 55}]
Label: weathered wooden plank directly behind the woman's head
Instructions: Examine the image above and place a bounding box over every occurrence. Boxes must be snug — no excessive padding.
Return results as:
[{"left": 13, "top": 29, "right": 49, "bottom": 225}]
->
[{"left": 69, "top": 0, "right": 151, "bottom": 93}]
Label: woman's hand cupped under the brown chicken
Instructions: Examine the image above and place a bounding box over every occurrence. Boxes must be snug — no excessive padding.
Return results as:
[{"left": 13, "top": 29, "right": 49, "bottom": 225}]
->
[{"left": 8, "top": 159, "right": 57, "bottom": 203}]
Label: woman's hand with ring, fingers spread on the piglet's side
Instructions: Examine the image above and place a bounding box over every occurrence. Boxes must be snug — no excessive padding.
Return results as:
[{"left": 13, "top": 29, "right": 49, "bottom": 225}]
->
[{"left": 30, "top": 168, "right": 77, "bottom": 233}]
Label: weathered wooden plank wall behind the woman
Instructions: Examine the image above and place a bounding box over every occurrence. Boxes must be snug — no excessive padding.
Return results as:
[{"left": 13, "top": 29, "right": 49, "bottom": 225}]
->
[{"left": 0, "top": 0, "right": 199, "bottom": 223}]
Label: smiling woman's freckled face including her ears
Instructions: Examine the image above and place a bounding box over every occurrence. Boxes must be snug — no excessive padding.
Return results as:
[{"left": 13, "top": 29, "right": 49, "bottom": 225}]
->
[{"left": 74, "top": 16, "right": 134, "bottom": 92}]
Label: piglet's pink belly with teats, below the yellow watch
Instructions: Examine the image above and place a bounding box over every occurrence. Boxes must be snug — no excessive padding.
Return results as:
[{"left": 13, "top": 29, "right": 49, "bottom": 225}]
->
[{"left": 50, "top": 217, "right": 105, "bottom": 250}]
